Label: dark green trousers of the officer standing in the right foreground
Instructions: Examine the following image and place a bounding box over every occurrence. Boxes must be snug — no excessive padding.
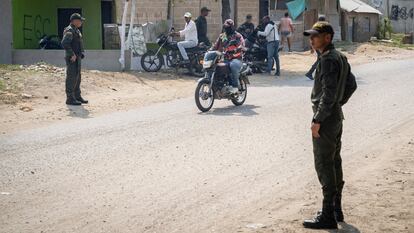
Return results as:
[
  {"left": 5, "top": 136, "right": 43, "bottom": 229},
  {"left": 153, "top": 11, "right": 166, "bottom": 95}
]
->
[{"left": 313, "top": 110, "right": 344, "bottom": 209}]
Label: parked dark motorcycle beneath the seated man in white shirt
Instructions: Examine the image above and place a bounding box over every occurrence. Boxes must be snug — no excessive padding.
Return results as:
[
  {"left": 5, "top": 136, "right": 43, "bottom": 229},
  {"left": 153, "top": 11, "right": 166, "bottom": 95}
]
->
[{"left": 141, "top": 30, "right": 208, "bottom": 77}]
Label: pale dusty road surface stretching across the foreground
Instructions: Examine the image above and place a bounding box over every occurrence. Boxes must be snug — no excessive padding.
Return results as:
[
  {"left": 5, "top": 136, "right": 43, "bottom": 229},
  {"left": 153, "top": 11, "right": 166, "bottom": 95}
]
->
[{"left": 0, "top": 59, "right": 414, "bottom": 233}]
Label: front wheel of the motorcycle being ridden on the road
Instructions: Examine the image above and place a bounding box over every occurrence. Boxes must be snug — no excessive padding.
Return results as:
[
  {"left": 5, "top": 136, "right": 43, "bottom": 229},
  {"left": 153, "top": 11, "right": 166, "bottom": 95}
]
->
[{"left": 195, "top": 79, "right": 214, "bottom": 112}]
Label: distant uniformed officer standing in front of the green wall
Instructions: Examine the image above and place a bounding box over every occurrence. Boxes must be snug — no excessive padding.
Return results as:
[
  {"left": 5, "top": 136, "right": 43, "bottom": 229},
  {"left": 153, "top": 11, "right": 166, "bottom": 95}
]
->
[{"left": 62, "top": 13, "right": 88, "bottom": 105}]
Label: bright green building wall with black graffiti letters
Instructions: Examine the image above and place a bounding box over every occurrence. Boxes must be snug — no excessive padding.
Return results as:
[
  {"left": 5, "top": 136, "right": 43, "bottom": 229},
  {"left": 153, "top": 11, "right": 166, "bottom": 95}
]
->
[{"left": 12, "top": 0, "right": 102, "bottom": 49}]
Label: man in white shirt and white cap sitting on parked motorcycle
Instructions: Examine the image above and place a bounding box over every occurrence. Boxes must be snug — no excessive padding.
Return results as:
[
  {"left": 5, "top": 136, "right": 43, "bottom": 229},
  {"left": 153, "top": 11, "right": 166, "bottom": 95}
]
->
[{"left": 174, "top": 12, "right": 198, "bottom": 64}]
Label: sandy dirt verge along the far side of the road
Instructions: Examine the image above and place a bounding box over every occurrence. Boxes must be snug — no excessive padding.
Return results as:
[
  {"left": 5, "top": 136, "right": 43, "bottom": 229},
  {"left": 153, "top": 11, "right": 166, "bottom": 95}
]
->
[{"left": 0, "top": 43, "right": 414, "bottom": 134}]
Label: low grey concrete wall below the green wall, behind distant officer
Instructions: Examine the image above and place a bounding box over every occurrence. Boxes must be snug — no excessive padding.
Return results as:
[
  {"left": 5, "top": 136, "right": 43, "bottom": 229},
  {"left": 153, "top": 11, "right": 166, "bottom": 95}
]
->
[{"left": 13, "top": 49, "right": 131, "bottom": 71}]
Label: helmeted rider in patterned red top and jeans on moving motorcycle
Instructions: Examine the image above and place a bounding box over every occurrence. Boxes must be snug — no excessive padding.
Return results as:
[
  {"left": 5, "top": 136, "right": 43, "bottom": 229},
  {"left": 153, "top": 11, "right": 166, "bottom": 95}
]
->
[{"left": 212, "top": 19, "right": 244, "bottom": 94}]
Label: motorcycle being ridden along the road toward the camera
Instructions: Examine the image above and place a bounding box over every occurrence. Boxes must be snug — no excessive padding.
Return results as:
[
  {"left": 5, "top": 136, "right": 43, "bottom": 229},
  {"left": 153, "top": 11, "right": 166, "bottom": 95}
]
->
[{"left": 195, "top": 51, "right": 251, "bottom": 112}]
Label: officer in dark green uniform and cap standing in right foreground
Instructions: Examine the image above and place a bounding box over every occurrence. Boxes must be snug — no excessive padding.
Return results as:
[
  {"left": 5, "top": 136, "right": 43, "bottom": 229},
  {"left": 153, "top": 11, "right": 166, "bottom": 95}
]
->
[{"left": 303, "top": 22, "right": 357, "bottom": 229}]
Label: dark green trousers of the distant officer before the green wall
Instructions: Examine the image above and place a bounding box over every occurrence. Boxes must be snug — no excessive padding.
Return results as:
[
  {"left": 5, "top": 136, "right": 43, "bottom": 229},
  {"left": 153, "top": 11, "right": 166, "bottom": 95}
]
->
[{"left": 65, "top": 58, "right": 82, "bottom": 98}]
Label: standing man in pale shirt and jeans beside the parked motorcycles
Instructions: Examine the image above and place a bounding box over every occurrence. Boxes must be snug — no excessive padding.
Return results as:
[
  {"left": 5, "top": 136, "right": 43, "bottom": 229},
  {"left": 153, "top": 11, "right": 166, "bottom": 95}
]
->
[{"left": 257, "top": 16, "right": 280, "bottom": 76}]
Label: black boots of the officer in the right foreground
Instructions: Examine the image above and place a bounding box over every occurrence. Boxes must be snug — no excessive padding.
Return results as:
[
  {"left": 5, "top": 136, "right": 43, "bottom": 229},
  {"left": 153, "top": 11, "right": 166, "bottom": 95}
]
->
[{"left": 303, "top": 205, "right": 338, "bottom": 229}]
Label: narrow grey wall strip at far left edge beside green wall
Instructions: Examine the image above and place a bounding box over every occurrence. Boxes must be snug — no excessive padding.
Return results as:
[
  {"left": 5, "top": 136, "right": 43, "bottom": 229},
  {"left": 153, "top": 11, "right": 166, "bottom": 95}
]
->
[{"left": 0, "top": 0, "right": 13, "bottom": 64}]
